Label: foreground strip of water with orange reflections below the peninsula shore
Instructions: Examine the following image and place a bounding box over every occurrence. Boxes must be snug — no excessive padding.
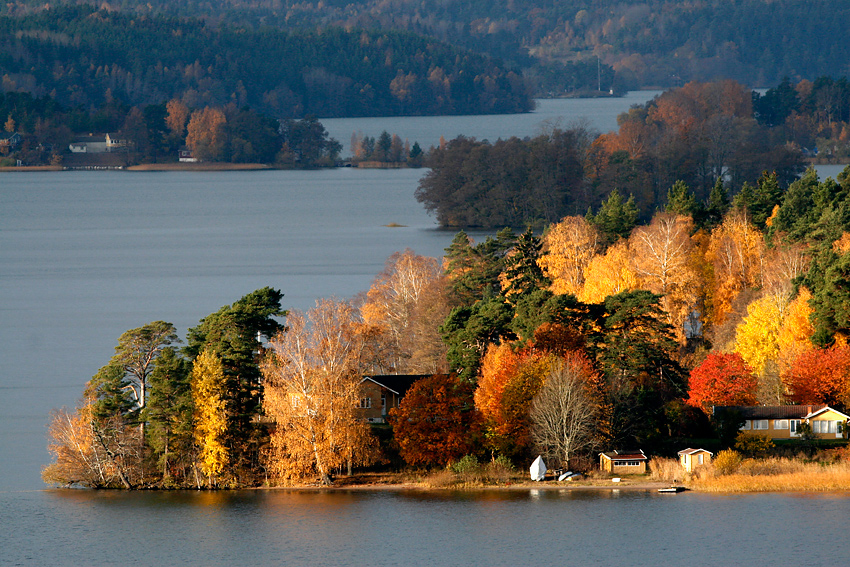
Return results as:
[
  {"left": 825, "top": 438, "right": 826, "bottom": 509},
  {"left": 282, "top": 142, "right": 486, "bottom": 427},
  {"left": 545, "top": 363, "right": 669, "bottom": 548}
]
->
[{"left": 0, "top": 489, "right": 850, "bottom": 566}]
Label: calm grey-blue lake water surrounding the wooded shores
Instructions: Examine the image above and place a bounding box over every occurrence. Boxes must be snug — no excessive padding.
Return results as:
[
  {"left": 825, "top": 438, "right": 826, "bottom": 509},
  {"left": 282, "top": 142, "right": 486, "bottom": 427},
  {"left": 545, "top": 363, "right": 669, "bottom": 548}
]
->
[{"left": 0, "top": 93, "right": 848, "bottom": 565}]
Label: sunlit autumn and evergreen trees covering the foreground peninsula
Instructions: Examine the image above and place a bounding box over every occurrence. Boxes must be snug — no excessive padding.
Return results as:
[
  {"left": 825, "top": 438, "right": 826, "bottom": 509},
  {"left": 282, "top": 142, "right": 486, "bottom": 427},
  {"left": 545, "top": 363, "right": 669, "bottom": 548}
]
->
[{"left": 43, "top": 153, "right": 850, "bottom": 490}]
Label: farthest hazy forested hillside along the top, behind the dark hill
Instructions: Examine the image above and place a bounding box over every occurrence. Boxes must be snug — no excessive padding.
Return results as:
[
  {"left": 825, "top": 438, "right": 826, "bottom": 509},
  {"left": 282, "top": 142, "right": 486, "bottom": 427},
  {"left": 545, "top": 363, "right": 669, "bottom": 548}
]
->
[{"left": 0, "top": 0, "right": 850, "bottom": 93}]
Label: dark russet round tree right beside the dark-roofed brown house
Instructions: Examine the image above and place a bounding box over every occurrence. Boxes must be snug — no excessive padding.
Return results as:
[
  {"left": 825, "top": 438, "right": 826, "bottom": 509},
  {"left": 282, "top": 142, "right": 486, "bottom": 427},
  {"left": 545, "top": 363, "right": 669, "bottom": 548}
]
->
[{"left": 389, "top": 374, "right": 480, "bottom": 466}]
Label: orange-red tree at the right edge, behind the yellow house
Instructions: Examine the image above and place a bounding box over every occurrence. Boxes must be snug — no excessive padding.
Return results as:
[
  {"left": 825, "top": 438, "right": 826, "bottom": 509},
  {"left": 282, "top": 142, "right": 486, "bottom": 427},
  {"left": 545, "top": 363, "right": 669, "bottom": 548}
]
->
[{"left": 785, "top": 346, "right": 850, "bottom": 408}]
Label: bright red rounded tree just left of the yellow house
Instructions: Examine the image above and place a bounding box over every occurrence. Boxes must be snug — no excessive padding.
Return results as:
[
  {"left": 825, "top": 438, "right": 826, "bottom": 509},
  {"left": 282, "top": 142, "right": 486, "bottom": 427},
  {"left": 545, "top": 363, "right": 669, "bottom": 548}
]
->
[{"left": 686, "top": 352, "right": 758, "bottom": 412}]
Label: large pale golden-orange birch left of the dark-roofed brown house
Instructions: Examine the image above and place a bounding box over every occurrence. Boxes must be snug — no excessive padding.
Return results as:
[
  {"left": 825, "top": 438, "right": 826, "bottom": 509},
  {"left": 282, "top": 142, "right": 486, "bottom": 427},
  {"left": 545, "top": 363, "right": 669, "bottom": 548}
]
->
[{"left": 261, "top": 300, "right": 372, "bottom": 484}]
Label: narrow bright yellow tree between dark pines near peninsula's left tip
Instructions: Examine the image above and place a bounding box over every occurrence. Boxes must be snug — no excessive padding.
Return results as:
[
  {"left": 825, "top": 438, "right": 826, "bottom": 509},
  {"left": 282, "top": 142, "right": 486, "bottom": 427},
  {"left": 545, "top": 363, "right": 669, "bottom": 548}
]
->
[{"left": 190, "top": 350, "right": 229, "bottom": 486}]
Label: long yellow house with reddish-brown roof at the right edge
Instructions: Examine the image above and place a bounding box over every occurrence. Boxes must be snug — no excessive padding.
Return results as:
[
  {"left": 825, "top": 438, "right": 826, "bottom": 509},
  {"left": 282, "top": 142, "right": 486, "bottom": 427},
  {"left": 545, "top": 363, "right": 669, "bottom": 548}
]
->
[{"left": 712, "top": 405, "right": 850, "bottom": 440}]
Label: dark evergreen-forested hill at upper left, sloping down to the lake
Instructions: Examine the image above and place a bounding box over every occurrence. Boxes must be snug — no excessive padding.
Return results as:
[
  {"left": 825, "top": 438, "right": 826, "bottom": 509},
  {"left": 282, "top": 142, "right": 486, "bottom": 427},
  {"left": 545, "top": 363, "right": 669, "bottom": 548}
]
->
[{"left": 0, "top": 6, "right": 532, "bottom": 118}]
